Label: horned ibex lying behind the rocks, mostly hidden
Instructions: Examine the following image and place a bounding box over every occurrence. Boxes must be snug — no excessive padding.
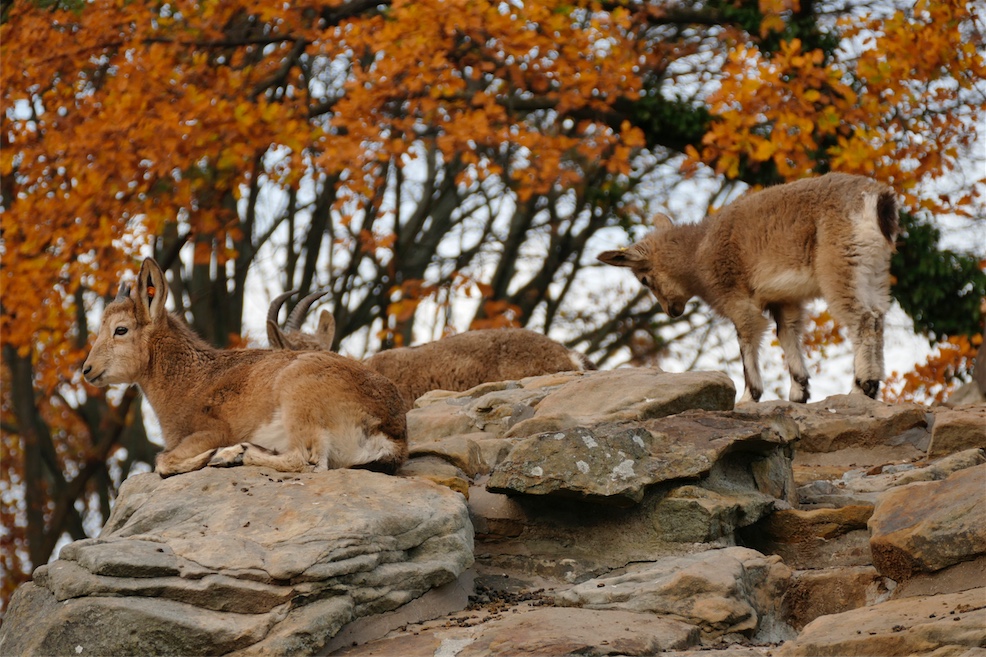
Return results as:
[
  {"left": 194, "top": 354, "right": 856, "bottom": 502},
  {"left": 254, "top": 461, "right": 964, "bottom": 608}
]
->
[{"left": 267, "top": 293, "right": 596, "bottom": 406}]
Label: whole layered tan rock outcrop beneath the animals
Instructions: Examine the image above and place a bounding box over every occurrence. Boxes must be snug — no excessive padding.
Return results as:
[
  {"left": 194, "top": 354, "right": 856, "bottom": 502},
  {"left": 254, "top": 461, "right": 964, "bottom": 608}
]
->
[{"left": 0, "top": 368, "right": 986, "bottom": 657}]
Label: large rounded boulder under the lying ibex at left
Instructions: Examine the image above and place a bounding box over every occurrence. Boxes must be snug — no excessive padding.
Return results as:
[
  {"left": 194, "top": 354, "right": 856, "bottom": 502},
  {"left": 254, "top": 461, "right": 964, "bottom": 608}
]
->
[{"left": 0, "top": 468, "right": 473, "bottom": 655}]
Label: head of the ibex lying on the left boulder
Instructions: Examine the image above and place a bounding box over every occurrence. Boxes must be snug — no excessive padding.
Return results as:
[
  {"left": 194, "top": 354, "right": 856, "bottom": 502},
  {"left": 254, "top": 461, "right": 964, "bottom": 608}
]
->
[{"left": 82, "top": 258, "right": 168, "bottom": 387}]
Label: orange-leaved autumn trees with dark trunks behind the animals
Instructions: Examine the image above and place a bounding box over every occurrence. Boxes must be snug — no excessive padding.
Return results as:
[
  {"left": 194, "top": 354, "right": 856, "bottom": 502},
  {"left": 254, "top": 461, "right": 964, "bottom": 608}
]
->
[{"left": 0, "top": 0, "right": 986, "bottom": 599}]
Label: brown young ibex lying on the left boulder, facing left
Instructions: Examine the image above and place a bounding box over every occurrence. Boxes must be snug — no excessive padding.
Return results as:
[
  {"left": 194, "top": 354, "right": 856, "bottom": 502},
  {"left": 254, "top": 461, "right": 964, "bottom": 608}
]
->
[{"left": 83, "top": 259, "right": 407, "bottom": 477}]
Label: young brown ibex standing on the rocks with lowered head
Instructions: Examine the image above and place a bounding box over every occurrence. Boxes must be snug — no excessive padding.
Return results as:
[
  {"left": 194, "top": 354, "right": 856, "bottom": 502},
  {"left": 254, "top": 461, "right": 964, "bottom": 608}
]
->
[{"left": 599, "top": 173, "right": 898, "bottom": 402}]
